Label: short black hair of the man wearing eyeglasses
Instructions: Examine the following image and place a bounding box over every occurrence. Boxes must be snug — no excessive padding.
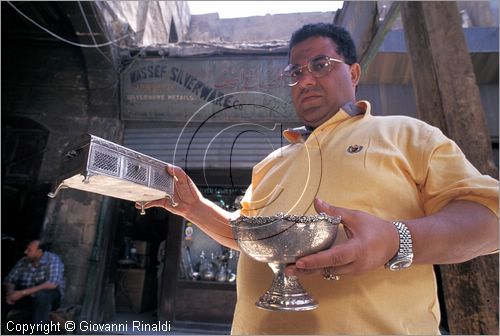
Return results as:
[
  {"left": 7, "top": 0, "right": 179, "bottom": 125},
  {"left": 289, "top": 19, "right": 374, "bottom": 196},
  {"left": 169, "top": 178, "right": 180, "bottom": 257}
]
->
[{"left": 288, "top": 23, "right": 357, "bottom": 65}]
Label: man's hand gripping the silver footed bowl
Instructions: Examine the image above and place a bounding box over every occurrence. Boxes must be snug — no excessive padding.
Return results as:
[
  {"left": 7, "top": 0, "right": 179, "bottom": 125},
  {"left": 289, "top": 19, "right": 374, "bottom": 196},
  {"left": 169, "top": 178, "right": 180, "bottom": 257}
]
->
[{"left": 287, "top": 198, "right": 399, "bottom": 275}]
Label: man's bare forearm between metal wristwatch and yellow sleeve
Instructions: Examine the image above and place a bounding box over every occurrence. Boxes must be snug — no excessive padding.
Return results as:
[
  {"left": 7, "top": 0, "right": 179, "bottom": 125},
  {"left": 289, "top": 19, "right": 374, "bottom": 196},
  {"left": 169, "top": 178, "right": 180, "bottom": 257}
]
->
[{"left": 406, "top": 201, "right": 499, "bottom": 264}]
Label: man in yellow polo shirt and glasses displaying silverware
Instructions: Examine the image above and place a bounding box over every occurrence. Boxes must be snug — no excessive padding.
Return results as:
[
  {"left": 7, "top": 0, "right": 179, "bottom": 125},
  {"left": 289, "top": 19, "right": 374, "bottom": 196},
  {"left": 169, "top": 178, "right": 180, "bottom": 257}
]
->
[{"left": 143, "top": 24, "right": 499, "bottom": 334}]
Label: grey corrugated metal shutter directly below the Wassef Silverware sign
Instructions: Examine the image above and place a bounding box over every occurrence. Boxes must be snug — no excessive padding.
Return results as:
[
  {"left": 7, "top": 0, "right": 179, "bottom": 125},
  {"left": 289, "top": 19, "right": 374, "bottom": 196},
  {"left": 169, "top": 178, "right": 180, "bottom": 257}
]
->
[{"left": 123, "top": 123, "right": 297, "bottom": 170}]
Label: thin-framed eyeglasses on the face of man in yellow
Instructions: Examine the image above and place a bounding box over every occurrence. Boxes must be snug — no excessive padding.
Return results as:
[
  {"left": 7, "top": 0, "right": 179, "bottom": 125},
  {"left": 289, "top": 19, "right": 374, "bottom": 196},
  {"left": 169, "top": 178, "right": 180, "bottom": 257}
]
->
[{"left": 282, "top": 55, "right": 345, "bottom": 86}]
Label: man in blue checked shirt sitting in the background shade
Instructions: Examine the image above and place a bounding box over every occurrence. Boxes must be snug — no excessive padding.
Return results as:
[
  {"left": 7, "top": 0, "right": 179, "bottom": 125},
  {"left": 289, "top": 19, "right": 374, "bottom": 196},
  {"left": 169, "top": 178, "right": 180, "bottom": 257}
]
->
[{"left": 3, "top": 240, "right": 65, "bottom": 323}]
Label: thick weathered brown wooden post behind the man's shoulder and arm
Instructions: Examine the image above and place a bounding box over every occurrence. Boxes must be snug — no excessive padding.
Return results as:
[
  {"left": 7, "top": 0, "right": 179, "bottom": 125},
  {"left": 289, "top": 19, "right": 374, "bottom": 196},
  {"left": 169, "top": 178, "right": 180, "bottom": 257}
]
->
[{"left": 401, "top": 1, "right": 498, "bottom": 334}]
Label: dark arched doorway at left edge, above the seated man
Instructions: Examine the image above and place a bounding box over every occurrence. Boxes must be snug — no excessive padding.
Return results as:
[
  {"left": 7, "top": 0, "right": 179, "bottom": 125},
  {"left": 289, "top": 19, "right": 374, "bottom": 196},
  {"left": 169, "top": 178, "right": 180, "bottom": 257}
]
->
[{"left": 2, "top": 117, "right": 50, "bottom": 275}]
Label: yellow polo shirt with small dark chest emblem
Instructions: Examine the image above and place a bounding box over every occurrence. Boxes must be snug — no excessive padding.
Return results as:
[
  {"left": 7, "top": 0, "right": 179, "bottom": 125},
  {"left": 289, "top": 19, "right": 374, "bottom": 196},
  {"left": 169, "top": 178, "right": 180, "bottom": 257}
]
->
[{"left": 232, "top": 101, "right": 499, "bottom": 335}]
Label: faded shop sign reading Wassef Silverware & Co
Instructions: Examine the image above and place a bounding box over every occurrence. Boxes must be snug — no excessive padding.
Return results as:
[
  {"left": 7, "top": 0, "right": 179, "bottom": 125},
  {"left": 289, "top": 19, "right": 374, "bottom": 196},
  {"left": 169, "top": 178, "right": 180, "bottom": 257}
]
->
[{"left": 121, "top": 56, "right": 296, "bottom": 122}]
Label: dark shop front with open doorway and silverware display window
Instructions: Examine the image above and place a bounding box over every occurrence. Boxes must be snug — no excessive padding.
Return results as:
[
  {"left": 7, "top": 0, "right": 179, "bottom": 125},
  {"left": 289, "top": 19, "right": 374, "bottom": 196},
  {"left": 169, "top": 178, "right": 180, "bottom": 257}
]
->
[{"left": 110, "top": 187, "right": 244, "bottom": 330}]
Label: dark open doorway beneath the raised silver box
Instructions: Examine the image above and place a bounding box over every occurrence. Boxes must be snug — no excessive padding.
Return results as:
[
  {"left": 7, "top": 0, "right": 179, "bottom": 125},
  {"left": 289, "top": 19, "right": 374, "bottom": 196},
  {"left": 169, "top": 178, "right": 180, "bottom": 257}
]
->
[{"left": 106, "top": 201, "right": 168, "bottom": 323}]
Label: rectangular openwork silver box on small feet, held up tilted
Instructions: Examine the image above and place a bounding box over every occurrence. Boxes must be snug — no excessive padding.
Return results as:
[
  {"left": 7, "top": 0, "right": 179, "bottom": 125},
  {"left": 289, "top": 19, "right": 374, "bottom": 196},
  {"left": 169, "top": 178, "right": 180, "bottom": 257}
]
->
[{"left": 49, "top": 134, "right": 174, "bottom": 210}]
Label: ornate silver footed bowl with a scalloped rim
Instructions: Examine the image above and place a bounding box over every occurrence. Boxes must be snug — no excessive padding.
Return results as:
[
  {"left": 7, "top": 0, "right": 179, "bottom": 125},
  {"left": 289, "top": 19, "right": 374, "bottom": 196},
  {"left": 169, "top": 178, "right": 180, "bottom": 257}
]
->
[{"left": 231, "top": 213, "right": 340, "bottom": 311}]
